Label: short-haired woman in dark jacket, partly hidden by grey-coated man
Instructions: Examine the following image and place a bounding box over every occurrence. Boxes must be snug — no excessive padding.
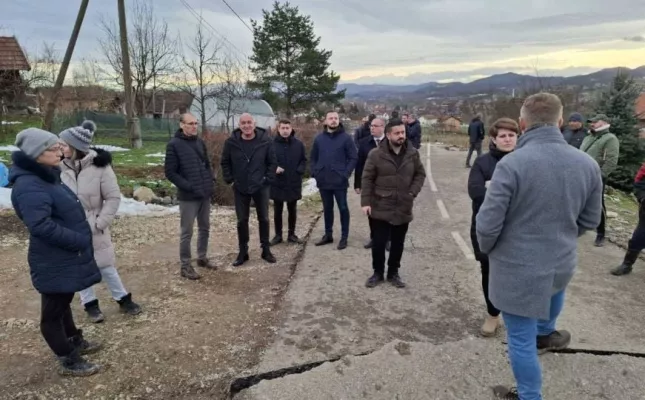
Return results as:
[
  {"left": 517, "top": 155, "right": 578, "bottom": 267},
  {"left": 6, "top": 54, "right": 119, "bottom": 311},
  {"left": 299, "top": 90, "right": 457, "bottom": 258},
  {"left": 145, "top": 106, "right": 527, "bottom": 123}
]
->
[{"left": 468, "top": 118, "right": 519, "bottom": 337}]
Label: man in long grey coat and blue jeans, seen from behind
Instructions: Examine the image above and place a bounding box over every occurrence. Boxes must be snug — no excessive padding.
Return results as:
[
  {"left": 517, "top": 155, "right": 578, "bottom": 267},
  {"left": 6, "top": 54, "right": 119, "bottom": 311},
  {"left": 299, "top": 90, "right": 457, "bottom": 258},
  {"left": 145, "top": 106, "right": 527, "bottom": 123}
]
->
[{"left": 476, "top": 93, "right": 602, "bottom": 400}]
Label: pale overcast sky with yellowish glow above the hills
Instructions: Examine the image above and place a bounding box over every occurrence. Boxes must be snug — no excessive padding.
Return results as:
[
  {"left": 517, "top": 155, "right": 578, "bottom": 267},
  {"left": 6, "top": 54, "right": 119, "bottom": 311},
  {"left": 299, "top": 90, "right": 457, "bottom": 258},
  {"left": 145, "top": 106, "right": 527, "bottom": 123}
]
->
[{"left": 0, "top": 0, "right": 645, "bottom": 83}]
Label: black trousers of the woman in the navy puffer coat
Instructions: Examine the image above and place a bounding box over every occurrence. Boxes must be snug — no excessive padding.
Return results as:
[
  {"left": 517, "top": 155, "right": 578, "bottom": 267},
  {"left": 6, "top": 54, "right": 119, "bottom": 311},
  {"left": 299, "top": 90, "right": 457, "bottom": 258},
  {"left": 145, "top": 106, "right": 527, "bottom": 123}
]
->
[{"left": 40, "top": 293, "right": 78, "bottom": 357}]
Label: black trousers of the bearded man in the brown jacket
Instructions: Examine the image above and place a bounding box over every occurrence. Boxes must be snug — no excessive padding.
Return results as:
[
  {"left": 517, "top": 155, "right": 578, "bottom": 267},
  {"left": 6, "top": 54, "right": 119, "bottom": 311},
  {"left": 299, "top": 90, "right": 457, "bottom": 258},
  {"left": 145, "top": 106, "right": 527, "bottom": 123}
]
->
[{"left": 372, "top": 219, "right": 409, "bottom": 277}]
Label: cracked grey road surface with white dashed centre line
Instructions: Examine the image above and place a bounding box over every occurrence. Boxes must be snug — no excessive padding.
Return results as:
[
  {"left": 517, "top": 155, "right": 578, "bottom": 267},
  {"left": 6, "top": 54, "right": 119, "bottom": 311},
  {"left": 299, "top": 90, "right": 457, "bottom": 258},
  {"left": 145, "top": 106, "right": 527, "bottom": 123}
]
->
[{"left": 234, "top": 145, "right": 645, "bottom": 400}]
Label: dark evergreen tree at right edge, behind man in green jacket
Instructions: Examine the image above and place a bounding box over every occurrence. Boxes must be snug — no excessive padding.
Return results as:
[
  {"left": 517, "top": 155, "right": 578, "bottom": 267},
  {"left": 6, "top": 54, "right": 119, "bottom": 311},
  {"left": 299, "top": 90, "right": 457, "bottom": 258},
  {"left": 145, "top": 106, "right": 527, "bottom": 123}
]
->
[{"left": 596, "top": 72, "right": 645, "bottom": 191}]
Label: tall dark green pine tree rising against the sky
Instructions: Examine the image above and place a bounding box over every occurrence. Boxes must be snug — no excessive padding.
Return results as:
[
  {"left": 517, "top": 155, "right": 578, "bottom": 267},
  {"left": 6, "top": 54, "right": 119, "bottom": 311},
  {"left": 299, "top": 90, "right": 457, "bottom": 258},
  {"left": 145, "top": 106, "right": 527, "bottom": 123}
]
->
[{"left": 249, "top": 1, "right": 345, "bottom": 116}]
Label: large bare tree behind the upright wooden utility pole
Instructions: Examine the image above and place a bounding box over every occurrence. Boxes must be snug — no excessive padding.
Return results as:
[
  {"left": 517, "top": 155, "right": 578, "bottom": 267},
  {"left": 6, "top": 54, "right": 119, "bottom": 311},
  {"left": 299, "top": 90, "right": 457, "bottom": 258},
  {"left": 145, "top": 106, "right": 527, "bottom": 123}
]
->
[{"left": 99, "top": 0, "right": 177, "bottom": 115}]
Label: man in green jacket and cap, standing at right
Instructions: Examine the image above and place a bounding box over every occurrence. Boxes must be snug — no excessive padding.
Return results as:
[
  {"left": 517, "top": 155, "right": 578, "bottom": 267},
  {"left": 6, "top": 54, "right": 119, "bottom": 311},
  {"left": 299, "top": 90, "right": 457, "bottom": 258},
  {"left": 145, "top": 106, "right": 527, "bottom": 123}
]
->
[{"left": 580, "top": 114, "right": 620, "bottom": 247}]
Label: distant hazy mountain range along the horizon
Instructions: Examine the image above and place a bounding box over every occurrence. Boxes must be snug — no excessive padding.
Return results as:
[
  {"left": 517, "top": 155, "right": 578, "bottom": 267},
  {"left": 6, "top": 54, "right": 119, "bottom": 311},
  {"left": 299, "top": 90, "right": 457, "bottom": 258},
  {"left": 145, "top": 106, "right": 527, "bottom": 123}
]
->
[{"left": 338, "top": 66, "right": 645, "bottom": 100}]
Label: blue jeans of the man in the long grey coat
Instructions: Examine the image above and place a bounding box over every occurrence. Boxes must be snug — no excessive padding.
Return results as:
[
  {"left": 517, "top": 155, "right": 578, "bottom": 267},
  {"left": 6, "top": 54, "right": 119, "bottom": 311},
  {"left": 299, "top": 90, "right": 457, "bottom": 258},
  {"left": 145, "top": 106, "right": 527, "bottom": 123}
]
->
[{"left": 502, "top": 290, "right": 564, "bottom": 400}]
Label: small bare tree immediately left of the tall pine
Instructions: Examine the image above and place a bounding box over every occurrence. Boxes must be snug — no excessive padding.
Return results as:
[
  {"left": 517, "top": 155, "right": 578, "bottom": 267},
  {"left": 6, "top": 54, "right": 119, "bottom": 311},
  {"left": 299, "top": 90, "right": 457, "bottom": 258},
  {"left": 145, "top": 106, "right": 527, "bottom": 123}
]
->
[{"left": 213, "top": 56, "right": 251, "bottom": 132}]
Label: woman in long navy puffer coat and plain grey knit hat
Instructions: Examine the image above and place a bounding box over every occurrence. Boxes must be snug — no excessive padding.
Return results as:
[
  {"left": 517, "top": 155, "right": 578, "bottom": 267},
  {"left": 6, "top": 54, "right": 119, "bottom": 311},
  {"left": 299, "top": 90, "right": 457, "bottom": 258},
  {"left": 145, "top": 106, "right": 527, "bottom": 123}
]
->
[{"left": 9, "top": 128, "right": 101, "bottom": 376}]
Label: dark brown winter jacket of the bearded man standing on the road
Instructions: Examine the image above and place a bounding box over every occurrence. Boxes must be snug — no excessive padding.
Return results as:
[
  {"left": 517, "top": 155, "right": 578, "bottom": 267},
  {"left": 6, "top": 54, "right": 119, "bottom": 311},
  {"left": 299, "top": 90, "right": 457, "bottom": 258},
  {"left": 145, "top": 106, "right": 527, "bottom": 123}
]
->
[{"left": 361, "top": 140, "right": 426, "bottom": 225}]
